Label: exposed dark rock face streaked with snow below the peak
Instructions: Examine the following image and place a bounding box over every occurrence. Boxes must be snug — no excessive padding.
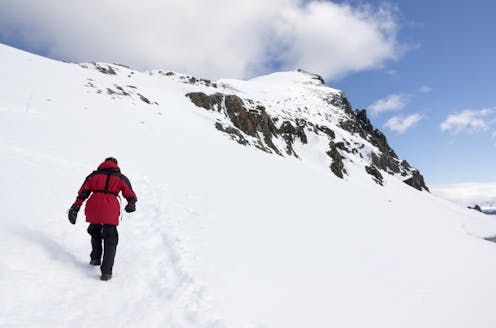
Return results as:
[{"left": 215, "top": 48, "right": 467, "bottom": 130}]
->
[{"left": 186, "top": 76, "right": 429, "bottom": 191}]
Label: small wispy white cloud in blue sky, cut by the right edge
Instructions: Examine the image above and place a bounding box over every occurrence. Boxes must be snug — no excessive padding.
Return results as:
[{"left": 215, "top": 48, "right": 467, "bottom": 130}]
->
[{"left": 440, "top": 109, "right": 496, "bottom": 134}]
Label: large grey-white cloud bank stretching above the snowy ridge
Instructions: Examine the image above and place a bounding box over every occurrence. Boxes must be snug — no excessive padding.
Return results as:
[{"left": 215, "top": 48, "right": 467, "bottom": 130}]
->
[{"left": 0, "top": 0, "right": 404, "bottom": 79}]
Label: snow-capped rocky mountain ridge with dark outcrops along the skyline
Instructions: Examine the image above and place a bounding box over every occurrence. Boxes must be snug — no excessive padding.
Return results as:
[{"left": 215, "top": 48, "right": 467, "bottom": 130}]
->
[{"left": 77, "top": 63, "right": 428, "bottom": 191}]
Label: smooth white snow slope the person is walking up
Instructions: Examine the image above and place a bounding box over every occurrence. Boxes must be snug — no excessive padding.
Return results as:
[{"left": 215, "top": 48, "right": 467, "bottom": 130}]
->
[{"left": 0, "top": 45, "right": 496, "bottom": 328}]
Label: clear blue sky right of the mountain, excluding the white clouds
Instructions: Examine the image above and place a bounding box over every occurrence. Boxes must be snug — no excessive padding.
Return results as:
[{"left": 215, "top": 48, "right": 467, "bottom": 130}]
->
[{"left": 331, "top": 0, "right": 496, "bottom": 184}]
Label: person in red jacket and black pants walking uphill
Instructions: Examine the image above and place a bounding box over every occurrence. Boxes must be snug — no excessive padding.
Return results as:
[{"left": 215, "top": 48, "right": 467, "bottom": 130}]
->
[{"left": 68, "top": 157, "right": 137, "bottom": 281}]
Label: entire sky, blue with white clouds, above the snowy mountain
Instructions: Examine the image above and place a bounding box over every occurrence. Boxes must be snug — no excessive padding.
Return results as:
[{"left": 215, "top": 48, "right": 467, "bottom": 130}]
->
[{"left": 0, "top": 0, "right": 496, "bottom": 185}]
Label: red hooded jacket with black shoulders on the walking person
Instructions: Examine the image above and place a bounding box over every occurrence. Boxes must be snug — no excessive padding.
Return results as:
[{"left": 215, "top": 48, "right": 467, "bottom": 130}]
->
[{"left": 75, "top": 160, "right": 137, "bottom": 225}]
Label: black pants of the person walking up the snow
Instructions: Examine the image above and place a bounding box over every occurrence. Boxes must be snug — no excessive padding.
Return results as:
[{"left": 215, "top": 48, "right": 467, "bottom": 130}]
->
[{"left": 88, "top": 223, "right": 119, "bottom": 273}]
